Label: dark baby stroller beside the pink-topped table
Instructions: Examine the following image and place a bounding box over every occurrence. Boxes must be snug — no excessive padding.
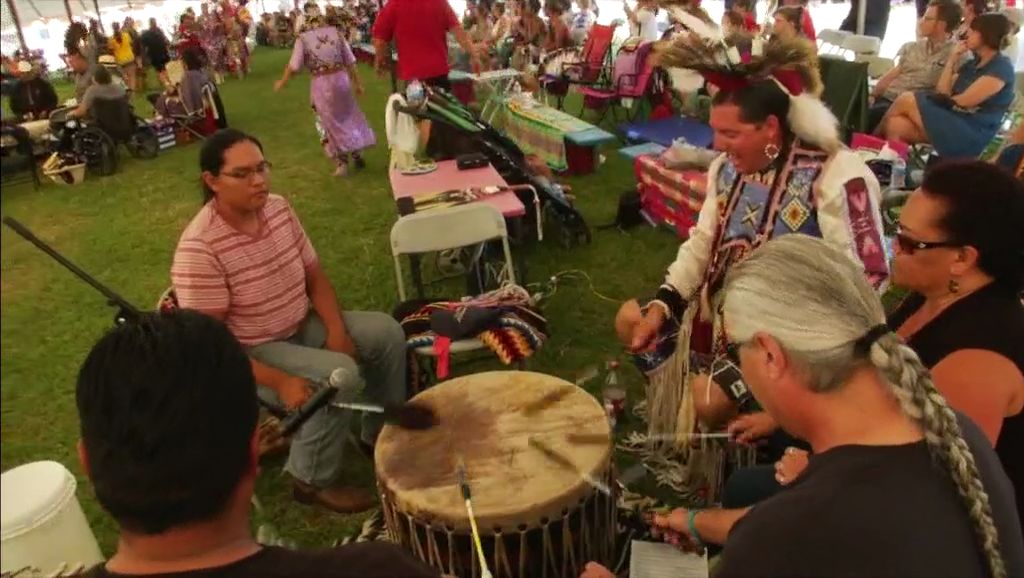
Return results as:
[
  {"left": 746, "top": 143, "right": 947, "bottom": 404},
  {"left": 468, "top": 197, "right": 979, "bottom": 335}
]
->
[{"left": 410, "top": 87, "right": 591, "bottom": 248}]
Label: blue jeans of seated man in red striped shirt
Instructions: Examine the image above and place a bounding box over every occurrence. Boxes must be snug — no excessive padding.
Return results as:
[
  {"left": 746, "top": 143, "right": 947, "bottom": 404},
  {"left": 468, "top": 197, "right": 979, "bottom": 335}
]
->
[{"left": 249, "top": 312, "right": 407, "bottom": 488}]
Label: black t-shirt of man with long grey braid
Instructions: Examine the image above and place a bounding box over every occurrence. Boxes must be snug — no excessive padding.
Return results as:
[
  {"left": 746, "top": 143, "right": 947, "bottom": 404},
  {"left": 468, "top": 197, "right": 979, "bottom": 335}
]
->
[{"left": 716, "top": 416, "right": 1024, "bottom": 578}]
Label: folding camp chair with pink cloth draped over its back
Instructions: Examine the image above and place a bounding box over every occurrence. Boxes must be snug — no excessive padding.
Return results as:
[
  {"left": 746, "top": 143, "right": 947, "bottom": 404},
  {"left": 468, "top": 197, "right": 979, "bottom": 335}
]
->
[{"left": 580, "top": 43, "right": 654, "bottom": 125}]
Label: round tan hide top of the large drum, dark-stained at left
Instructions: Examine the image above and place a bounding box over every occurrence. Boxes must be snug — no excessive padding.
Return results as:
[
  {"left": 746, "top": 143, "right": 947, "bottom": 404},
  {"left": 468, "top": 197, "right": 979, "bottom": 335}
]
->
[{"left": 375, "top": 371, "right": 611, "bottom": 533}]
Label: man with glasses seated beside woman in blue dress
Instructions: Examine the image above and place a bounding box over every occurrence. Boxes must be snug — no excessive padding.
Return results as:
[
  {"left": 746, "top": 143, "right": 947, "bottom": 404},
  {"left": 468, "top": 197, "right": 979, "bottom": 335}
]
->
[{"left": 867, "top": 0, "right": 963, "bottom": 130}]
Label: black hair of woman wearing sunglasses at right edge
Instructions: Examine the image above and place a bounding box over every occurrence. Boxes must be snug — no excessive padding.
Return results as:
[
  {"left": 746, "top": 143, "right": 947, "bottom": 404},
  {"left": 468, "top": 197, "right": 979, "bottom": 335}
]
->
[{"left": 921, "top": 161, "right": 1024, "bottom": 292}]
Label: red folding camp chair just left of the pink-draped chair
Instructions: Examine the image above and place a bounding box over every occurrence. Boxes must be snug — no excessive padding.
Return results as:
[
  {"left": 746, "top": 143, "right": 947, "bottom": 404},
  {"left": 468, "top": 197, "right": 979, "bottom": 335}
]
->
[{"left": 540, "top": 25, "right": 615, "bottom": 110}]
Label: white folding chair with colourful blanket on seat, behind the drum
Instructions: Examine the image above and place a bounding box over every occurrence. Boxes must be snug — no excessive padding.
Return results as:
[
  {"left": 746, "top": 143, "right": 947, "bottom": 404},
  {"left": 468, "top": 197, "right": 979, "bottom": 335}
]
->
[{"left": 391, "top": 203, "right": 516, "bottom": 357}]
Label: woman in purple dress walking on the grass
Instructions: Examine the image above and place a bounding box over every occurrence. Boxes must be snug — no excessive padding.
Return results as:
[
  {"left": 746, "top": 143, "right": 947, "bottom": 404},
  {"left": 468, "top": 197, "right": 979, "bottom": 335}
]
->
[{"left": 273, "top": 2, "right": 375, "bottom": 176}]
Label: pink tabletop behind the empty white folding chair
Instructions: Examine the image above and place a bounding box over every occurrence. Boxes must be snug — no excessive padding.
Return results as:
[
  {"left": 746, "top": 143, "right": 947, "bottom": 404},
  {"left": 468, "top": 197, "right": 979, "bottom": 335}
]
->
[{"left": 390, "top": 161, "right": 526, "bottom": 217}]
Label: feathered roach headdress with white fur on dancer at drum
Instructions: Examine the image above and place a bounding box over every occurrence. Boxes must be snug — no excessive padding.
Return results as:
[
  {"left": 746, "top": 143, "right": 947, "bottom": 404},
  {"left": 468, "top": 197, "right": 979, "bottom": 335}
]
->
[{"left": 655, "top": 5, "right": 842, "bottom": 152}]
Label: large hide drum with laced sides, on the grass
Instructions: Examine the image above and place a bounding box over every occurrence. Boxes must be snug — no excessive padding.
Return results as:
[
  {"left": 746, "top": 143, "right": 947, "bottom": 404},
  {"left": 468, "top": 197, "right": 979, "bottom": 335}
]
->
[{"left": 376, "top": 371, "right": 615, "bottom": 578}]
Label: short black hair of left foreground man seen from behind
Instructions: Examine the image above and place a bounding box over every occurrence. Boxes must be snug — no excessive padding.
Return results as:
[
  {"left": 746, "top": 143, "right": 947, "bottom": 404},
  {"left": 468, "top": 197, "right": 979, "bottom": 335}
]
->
[{"left": 77, "top": 311, "right": 259, "bottom": 534}]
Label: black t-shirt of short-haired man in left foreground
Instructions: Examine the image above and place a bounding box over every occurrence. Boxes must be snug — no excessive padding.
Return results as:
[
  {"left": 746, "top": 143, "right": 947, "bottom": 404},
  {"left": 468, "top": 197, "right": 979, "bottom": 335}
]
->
[{"left": 85, "top": 542, "right": 440, "bottom": 578}]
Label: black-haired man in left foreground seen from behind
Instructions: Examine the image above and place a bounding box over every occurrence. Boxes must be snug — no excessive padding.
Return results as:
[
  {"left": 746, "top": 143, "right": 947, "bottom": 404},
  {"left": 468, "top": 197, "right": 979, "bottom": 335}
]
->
[{"left": 76, "top": 311, "right": 438, "bottom": 578}]
